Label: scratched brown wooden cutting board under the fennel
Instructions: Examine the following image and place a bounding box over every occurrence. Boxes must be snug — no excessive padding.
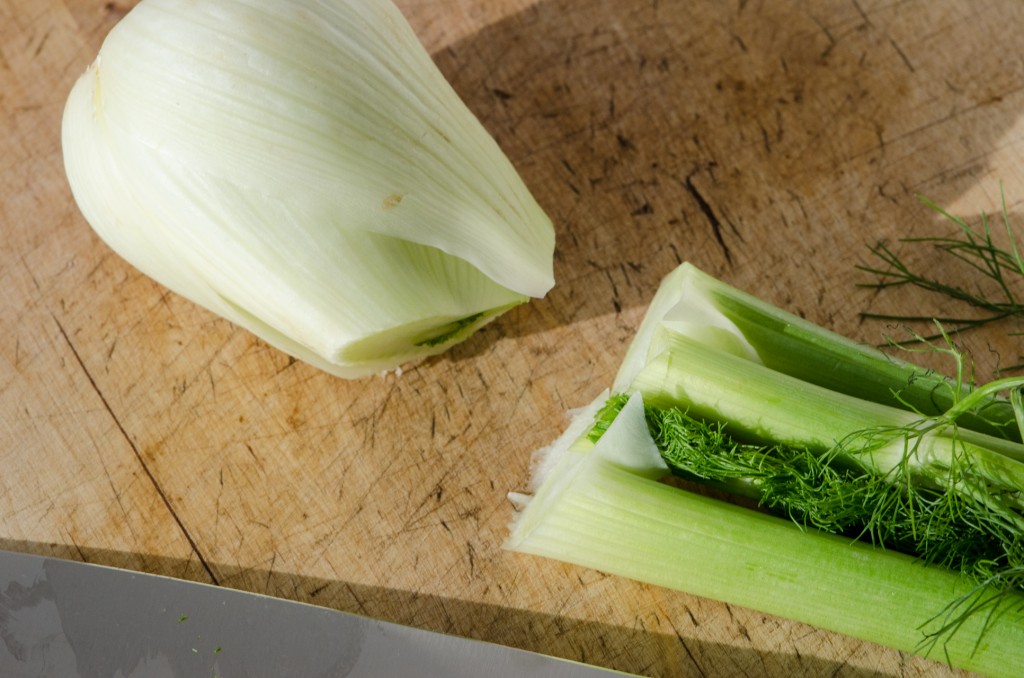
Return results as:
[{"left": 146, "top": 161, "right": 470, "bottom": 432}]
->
[{"left": 0, "top": 0, "right": 1024, "bottom": 676}]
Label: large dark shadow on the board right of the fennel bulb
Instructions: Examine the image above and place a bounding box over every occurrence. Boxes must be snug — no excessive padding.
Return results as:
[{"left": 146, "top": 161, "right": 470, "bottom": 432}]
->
[{"left": 433, "top": 0, "right": 1024, "bottom": 358}]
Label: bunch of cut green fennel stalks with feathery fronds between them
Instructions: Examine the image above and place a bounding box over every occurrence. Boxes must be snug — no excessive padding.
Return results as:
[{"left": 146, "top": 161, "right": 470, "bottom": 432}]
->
[{"left": 508, "top": 264, "right": 1024, "bottom": 676}]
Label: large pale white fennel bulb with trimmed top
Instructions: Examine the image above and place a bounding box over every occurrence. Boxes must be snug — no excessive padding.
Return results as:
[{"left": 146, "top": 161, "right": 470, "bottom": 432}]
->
[{"left": 62, "top": 0, "right": 554, "bottom": 378}]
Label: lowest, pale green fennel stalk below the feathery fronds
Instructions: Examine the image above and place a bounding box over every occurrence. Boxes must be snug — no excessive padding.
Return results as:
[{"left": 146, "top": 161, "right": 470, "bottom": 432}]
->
[{"left": 507, "top": 396, "right": 1024, "bottom": 678}]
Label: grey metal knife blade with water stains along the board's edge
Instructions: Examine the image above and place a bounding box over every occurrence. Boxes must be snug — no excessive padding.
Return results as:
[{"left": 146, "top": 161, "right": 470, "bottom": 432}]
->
[{"left": 0, "top": 550, "right": 626, "bottom": 678}]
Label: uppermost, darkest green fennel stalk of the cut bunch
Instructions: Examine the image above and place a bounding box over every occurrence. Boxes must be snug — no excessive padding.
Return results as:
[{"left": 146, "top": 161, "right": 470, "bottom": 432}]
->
[{"left": 612, "top": 263, "right": 1021, "bottom": 441}]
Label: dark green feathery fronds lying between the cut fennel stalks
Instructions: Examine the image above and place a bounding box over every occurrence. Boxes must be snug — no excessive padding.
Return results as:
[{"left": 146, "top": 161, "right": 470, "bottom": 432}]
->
[{"left": 588, "top": 394, "right": 1024, "bottom": 630}]
